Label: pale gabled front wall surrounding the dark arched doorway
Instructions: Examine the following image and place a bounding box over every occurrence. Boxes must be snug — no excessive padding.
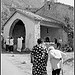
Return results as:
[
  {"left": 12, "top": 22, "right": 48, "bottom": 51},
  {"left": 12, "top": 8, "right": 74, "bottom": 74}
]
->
[{"left": 3, "top": 13, "right": 35, "bottom": 49}]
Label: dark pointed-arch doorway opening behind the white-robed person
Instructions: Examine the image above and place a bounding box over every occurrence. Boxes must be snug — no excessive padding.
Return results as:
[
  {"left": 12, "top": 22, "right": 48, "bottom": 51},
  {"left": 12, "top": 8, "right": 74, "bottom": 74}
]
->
[{"left": 9, "top": 19, "right": 26, "bottom": 49}]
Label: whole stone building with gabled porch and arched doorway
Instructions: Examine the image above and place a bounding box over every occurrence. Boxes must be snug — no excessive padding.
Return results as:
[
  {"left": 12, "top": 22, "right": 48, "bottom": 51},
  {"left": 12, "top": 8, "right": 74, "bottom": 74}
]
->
[{"left": 3, "top": 1, "right": 72, "bottom": 49}]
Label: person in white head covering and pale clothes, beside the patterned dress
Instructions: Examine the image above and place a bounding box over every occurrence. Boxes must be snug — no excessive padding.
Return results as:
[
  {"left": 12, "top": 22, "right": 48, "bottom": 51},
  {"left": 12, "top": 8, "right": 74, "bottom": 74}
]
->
[{"left": 49, "top": 46, "right": 66, "bottom": 75}]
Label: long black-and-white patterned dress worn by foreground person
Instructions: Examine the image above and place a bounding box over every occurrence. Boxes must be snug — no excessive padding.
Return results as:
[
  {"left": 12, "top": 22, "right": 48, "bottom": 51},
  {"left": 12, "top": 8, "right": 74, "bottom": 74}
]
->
[{"left": 31, "top": 45, "right": 48, "bottom": 75}]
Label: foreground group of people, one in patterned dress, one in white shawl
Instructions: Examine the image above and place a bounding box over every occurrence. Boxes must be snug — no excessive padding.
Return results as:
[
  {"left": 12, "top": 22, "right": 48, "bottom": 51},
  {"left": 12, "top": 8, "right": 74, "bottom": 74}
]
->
[{"left": 31, "top": 38, "right": 66, "bottom": 75}]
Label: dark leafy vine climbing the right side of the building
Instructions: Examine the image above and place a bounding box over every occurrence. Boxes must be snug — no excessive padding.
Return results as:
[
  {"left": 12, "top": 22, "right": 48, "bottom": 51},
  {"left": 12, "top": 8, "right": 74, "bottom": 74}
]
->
[{"left": 63, "top": 16, "right": 74, "bottom": 48}]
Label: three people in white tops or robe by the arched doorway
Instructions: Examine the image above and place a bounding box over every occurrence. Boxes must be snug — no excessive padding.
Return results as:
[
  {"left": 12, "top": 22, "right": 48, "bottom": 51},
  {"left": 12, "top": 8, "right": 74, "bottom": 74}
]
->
[{"left": 5, "top": 36, "right": 23, "bottom": 52}]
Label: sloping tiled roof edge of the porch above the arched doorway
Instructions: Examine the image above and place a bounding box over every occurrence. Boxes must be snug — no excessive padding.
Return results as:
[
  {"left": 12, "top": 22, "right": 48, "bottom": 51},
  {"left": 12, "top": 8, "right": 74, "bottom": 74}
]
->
[{"left": 3, "top": 9, "right": 65, "bottom": 26}]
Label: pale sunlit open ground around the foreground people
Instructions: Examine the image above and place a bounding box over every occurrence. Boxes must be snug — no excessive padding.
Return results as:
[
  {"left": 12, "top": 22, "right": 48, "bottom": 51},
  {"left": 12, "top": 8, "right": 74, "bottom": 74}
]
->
[{"left": 1, "top": 53, "right": 74, "bottom": 75}]
